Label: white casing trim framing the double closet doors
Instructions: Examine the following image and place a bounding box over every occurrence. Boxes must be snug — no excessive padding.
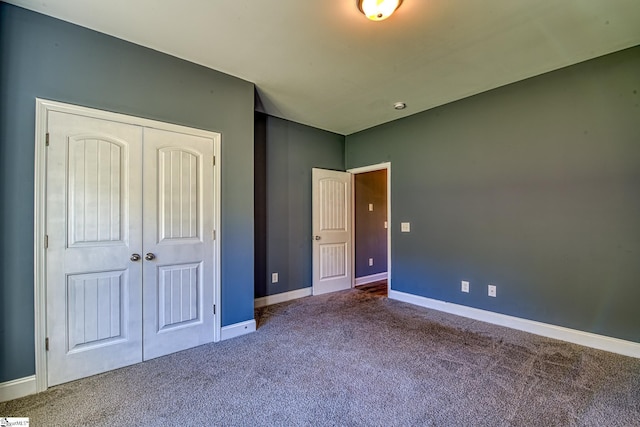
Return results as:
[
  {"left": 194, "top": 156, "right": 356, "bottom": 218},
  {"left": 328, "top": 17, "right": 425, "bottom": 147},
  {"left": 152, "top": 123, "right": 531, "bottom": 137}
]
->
[{"left": 33, "top": 98, "right": 222, "bottom": 392}]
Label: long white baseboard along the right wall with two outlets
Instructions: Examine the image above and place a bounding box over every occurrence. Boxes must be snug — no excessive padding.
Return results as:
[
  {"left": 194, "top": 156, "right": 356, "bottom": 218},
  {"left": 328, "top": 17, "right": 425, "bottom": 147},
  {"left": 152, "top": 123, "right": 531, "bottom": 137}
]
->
[{"left": 389, "top": 290, "right": 640, "bottom": 358}]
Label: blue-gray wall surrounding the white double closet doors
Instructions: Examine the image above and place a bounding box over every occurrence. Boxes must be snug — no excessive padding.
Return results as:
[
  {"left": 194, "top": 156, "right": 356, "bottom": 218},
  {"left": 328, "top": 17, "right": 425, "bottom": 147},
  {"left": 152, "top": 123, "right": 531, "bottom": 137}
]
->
[{"left": 0, "top": 3, "right": 254, "bottom": 382}]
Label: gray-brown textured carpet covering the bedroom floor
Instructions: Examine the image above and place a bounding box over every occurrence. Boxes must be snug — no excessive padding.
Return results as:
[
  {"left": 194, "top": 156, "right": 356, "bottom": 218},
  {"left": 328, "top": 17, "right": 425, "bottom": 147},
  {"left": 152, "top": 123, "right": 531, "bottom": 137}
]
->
[{"left": 0, "top": 289, "right": 640, "bottom": 426}]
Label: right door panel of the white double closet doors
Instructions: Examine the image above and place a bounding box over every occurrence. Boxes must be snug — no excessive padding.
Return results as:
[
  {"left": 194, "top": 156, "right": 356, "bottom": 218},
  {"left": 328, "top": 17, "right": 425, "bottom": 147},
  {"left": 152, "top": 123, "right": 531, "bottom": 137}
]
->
[{"left": 143, "top": 128, "right": 215, "bottom": 360}]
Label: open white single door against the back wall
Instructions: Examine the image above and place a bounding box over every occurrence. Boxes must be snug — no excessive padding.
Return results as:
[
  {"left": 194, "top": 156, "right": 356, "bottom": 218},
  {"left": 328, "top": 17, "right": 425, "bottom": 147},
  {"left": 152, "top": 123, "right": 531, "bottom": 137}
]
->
[{"left": 311, "top": 168, "right": 353, "bottom": 295}]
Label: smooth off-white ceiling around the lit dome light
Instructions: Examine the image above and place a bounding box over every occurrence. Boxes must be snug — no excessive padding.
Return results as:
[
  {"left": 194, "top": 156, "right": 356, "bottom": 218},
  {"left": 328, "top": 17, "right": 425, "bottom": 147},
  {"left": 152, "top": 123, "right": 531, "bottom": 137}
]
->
[{"left": 8, "top": 0, "right": 640, "bottom": 135}]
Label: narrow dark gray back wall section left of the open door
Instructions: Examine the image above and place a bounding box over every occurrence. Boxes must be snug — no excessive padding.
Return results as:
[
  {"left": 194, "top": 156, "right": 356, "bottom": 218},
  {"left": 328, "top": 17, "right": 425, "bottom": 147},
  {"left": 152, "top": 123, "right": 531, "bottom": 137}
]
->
[{"left": 256, "top": 114, "right": 345, "bottom": 297}]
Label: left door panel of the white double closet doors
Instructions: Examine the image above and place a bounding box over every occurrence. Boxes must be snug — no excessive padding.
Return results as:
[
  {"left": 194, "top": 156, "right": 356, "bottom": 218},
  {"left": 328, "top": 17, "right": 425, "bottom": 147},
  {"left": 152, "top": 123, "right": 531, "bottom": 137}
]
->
[{"left": 46, "top": 112, "right": 142, "bottom": 386}]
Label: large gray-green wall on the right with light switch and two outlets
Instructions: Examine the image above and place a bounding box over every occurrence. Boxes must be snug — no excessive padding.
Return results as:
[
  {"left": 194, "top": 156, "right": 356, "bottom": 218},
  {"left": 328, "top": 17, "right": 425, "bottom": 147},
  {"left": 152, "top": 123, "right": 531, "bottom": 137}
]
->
[{"left": 346, "top": 47, "right": 640, "bottom": 342}]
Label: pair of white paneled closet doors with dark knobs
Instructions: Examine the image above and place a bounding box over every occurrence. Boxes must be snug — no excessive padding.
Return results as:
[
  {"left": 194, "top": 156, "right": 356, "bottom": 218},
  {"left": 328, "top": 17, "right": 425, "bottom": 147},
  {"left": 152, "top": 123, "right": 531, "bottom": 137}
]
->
[{"left": 46, "top": 111, "right": 215, "bottom": 386}]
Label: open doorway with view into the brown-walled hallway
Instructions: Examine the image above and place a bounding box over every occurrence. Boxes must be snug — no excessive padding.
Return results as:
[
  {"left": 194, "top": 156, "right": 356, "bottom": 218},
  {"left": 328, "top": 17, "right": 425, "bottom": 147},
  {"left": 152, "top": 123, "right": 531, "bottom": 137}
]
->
[{"left": 349, "top": 163, "right": 391, "bottom": 296}]
